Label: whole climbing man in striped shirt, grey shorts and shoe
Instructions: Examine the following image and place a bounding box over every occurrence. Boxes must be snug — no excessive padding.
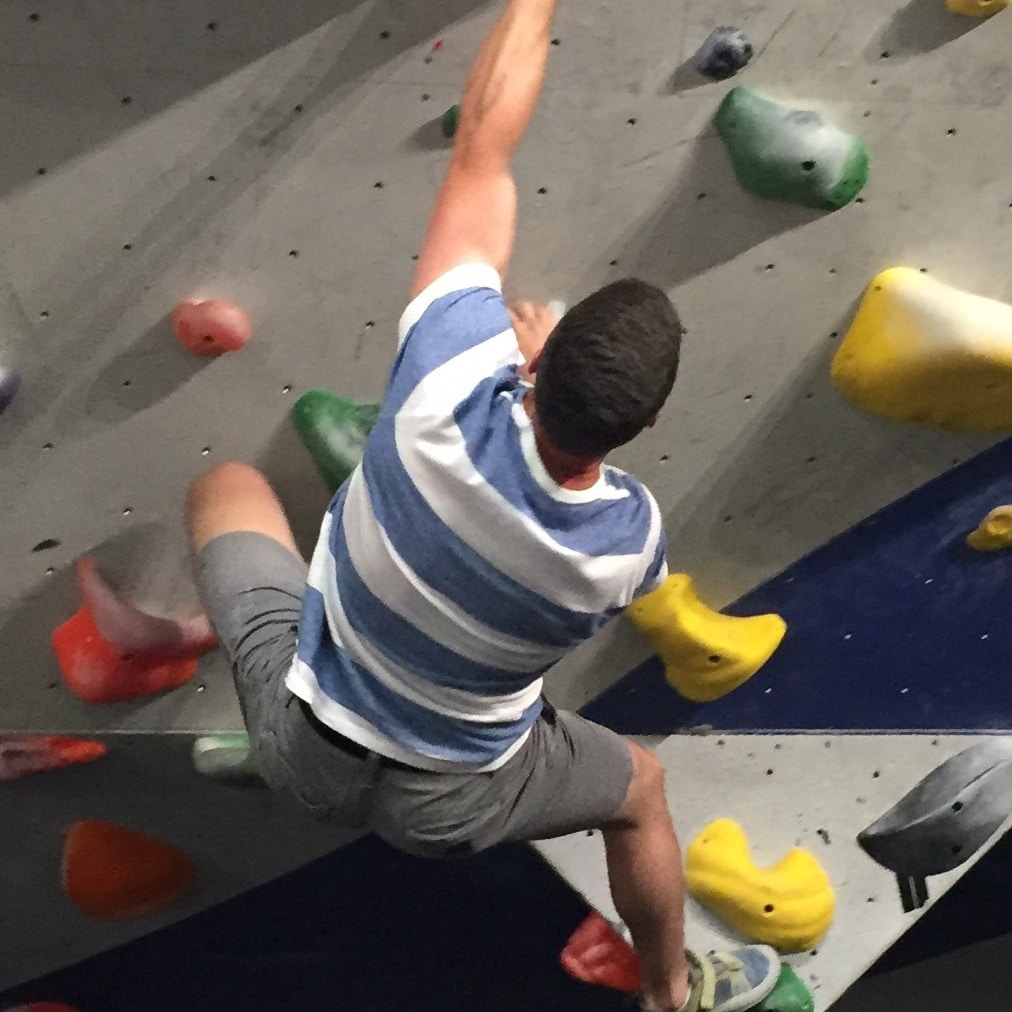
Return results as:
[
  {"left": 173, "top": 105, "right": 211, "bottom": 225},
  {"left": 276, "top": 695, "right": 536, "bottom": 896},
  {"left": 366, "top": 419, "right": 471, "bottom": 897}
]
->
[{"left": 188, "top": 0, "right": 779, "bottom": 1012}]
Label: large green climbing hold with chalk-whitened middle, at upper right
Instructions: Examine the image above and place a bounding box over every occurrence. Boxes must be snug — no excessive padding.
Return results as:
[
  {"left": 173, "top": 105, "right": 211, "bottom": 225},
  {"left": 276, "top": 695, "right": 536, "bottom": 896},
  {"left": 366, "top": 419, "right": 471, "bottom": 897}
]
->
[{"left": 713, "top": 87, "right": 868, "bottom": 210}]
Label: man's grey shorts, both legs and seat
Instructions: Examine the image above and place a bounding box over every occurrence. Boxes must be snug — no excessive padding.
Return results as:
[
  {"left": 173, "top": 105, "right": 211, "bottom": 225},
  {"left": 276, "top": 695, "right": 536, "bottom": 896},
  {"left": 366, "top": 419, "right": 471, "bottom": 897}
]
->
[{"left": 196, "top": 531, "right": 633, "bottom": 857}]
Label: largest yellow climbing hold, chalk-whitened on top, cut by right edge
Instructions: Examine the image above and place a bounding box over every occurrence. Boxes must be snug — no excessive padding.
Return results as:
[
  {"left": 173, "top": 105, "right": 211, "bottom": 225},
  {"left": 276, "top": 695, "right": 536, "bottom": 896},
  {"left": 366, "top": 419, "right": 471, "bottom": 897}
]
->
[{"left": 832, "top": 267, "right": 1012, "bottom": 432}]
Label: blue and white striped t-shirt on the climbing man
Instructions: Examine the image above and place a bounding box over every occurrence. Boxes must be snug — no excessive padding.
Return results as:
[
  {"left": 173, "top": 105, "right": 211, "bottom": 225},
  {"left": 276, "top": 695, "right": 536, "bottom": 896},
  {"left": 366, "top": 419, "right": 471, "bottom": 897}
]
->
[{"left": 287, "top": 264, "right": 667, "bottom": 770}]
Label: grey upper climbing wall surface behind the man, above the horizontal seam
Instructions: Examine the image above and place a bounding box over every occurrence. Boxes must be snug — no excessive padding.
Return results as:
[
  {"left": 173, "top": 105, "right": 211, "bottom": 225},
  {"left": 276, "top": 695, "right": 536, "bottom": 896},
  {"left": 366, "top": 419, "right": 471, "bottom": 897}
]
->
[{"left": 0, "top": 0, "right": 1012, "bottom": 1003}]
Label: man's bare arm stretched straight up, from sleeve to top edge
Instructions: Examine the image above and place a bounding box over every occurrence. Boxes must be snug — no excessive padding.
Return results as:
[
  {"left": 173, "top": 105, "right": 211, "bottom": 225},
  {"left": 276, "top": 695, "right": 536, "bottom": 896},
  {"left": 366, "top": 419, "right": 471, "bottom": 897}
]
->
[{"left": 411, "top": 0, "right": 558, "bottom": 298}]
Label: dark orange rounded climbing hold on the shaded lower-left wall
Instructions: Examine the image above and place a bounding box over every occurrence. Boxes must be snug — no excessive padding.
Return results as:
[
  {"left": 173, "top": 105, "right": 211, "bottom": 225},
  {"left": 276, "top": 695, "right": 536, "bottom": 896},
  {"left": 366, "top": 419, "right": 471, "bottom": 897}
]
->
[{"left": 63, "top": 819, "right": 193, "bottom": 918}]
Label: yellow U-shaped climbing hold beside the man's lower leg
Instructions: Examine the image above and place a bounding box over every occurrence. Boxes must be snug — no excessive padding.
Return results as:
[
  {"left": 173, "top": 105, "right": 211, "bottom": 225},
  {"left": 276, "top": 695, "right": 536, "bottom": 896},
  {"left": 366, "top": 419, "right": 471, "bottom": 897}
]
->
[{"left": 685, "top": 819, "right": 836, "bottom": 952}]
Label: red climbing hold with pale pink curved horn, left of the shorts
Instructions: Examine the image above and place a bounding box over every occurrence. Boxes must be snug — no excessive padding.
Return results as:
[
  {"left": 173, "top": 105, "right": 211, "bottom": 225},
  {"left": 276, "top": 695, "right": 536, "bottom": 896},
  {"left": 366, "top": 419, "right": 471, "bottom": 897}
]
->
[{"left": 52, "top": 559, "right": 218, "bottom": 702}]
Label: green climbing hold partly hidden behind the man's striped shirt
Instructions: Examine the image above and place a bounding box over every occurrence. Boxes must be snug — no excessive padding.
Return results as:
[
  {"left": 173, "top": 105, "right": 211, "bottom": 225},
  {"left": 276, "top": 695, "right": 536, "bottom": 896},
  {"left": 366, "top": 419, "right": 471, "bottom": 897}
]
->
[{"left": 291, "top": 390, "right": 380, "bottom": 493}]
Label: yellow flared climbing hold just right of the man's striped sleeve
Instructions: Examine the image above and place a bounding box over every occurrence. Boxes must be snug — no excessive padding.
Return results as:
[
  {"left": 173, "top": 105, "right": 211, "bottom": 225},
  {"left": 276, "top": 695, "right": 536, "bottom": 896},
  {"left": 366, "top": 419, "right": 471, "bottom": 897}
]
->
[{"left": 626, "top": 573, "right": 787, "bottom": 702}]
